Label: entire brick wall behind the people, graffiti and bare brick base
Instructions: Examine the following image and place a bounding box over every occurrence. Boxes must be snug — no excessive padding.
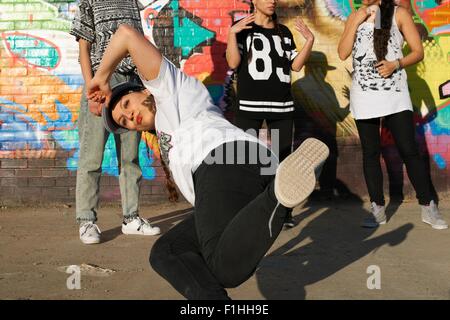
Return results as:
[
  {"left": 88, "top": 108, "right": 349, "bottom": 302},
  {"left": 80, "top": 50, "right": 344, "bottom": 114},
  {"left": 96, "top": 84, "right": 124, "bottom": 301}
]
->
[{"left": 0, "top": 0, "right": 450, "bottom": 202}]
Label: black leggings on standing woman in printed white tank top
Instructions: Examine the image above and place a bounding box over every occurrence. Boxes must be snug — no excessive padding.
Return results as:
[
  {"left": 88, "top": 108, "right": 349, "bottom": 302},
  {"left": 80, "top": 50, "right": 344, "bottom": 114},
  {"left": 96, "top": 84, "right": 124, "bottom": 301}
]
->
[{"left": 356, "top": 111, "right": 432, "bottom": 205}]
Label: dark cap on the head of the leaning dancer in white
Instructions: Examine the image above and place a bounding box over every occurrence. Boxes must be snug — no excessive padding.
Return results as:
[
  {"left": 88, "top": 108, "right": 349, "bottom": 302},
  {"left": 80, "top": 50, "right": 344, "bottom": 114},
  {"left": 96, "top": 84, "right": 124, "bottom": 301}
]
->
[{"left": 102, "top": 82, "right": 145, "bottom": 134}]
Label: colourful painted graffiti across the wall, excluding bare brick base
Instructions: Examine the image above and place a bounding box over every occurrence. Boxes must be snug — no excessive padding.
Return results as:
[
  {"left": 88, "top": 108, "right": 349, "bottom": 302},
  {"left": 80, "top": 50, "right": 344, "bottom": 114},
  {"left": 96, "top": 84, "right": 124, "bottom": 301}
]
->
[{"left": 0, "top": 0, "right": 450, "bottom": 192}]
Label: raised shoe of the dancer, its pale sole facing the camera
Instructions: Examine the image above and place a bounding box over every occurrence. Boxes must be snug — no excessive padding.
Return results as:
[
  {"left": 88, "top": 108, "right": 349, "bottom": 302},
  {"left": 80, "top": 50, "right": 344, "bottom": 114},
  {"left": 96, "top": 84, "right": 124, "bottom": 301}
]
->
[{"left": 275, "top": 138, "right": 329, "bottom": 208}]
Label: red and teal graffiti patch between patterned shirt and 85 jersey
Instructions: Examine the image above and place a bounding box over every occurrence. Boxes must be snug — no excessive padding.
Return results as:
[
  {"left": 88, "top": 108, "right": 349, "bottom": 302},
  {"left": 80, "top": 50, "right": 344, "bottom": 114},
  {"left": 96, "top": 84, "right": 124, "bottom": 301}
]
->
[{"left": 141, "top": 0, "right": 249, "bottom": 104}]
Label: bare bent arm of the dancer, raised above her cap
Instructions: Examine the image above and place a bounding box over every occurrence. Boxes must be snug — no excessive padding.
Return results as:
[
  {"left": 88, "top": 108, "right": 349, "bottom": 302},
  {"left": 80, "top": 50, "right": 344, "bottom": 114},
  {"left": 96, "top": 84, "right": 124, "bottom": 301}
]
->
[{"left": 88, "top": 24, "right": 162, "bottom": 103}]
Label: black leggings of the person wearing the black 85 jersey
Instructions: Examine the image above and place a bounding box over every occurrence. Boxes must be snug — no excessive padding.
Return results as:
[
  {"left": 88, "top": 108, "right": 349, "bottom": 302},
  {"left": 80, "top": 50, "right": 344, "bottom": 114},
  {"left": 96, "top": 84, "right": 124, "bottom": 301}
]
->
[{"left": 235, "top": 115, "right": 294, "bottom": 162}]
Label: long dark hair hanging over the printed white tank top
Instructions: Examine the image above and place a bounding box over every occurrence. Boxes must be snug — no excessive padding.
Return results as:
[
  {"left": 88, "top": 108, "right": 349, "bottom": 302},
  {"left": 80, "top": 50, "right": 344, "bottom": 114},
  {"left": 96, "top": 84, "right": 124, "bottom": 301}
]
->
[{"left": 373, "top": 0, "right": 395, "bottom": 61}]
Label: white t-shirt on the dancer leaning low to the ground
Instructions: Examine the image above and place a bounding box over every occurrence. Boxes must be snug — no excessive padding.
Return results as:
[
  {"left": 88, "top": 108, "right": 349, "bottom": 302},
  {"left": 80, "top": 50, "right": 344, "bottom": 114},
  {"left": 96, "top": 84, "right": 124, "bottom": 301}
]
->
[{"left": 141, "top": 57, "right": 262, "bottom": 205}]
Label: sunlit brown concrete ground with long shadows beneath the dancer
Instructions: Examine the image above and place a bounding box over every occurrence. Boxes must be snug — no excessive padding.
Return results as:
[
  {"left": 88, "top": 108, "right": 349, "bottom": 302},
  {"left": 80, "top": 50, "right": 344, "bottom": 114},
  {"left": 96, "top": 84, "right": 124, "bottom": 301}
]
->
[{"left": 0, "top": 201, "right": 450, "bottom": 300}]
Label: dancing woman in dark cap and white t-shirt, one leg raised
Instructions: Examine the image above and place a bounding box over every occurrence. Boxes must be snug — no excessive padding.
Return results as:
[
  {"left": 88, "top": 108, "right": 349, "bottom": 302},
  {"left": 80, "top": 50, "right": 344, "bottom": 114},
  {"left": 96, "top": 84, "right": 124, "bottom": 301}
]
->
[{"left": 88, "top": 25, "right": 328, "bottom": 299}]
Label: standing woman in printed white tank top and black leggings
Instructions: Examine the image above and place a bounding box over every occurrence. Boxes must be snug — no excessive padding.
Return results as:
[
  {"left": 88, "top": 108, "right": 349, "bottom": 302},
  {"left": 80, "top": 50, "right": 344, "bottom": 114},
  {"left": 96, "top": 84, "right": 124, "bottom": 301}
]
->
[{"left": 338, "top": 0, "right": 448, "bottom": 229}]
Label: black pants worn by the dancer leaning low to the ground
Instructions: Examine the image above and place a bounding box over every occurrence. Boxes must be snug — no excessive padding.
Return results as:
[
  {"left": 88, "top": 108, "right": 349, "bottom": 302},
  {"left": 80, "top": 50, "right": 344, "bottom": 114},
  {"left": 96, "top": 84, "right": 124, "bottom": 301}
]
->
[{"left": 150, "top": 143, "right": 287, "bottom": 299}]
